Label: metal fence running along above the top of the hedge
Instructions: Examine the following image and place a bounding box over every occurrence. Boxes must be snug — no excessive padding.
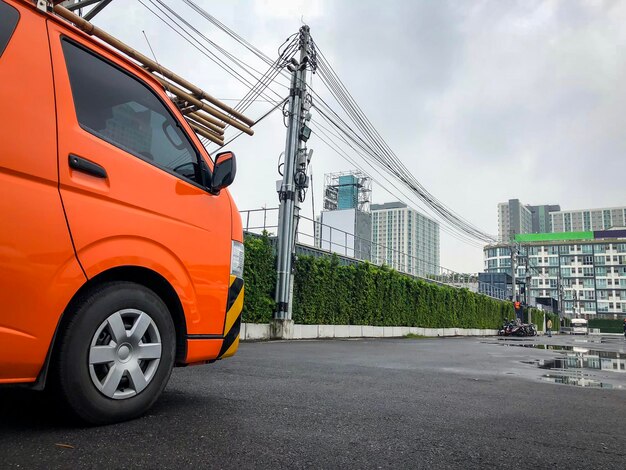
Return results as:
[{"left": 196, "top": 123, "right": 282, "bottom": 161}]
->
[{"left": 240, "top": 207, "right": 507, "bottom": 300}]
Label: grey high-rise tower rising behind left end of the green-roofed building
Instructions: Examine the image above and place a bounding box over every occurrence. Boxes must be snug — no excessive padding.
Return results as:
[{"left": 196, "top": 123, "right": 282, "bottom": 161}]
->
[{"left": 498, "top": 199, "right": 561, "bottom": 243}]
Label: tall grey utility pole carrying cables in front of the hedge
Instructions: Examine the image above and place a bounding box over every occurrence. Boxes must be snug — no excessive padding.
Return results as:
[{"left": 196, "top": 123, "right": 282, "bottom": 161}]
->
[{"left": 271, "top": 25, "right": 315, "bottom": 339}]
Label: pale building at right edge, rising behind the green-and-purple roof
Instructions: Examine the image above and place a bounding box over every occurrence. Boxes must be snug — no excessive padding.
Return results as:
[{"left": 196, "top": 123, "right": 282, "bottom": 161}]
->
[{"left": 550, "top": 207, "right": 626, "bottom": 232}]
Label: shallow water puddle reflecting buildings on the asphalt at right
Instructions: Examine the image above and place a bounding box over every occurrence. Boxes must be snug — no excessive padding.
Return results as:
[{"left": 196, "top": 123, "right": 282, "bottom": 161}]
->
[{"left": 499, "top": 341, "right": 626, "bottom": 390}]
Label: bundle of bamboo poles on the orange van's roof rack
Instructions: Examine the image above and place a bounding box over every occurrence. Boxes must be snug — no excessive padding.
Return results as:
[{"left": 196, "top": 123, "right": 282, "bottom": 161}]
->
[{"left": 54, "top": 5, "right": 254, "bottom": 145}]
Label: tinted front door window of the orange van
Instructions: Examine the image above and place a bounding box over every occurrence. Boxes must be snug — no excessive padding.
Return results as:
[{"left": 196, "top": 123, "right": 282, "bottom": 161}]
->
[{"left": 62, "top": 39, "right": 202, "bottom": 184}]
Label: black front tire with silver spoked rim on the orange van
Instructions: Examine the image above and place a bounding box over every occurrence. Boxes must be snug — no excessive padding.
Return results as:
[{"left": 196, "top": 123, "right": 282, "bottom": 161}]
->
[{"left": 54, "top": 282, "right": 176, "bottom": 424}]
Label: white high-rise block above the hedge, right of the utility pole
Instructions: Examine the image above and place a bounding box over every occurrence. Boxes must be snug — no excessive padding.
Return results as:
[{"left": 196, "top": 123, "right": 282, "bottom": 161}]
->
[{"left": 371, "top": 202, "right": 439, "bottom": 276}]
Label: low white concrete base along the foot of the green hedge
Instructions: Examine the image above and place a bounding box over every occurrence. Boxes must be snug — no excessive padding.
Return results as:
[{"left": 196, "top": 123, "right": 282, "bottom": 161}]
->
[{"left": 240, "top": 323, "right": 498, "bottom": 341}]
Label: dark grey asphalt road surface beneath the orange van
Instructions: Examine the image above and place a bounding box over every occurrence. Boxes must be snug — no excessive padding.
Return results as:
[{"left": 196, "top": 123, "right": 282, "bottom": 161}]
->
[{"left": 0, "top": 337, "right": 626, "bottom": 469}]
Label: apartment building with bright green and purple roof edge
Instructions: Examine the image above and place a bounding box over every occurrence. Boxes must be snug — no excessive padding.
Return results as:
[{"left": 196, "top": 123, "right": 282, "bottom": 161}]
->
[{"left": 484, "top": 229, "right": 626, "bottom": 317}]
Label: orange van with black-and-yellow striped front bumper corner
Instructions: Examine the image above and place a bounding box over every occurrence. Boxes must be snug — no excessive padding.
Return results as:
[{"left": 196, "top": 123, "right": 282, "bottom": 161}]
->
[{"left": 0, "top": 0, "right": 244, "bottom": 423}]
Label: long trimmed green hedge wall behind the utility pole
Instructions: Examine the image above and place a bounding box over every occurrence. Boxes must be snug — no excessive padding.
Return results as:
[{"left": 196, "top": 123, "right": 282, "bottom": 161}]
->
[{"left": 243, "top": 236, "right": 515, "bottom": 329}]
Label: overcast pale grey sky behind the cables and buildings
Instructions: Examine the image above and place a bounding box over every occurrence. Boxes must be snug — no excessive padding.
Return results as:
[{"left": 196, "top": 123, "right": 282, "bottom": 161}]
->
[{"left": 94, "top": 0, "right": 626, "bottom": 272}]
